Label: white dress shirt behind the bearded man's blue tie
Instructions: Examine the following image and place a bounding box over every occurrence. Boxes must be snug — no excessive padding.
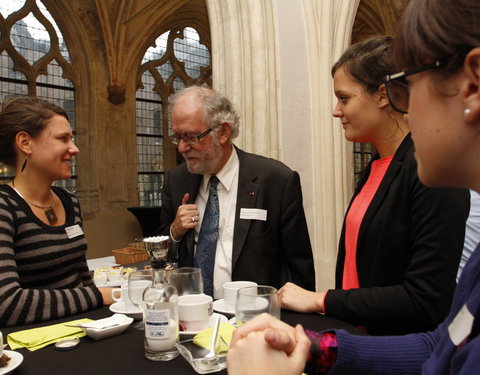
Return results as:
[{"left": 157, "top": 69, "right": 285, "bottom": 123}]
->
[{"left": 195, "top": 146, "right": 240, "bottom": 299}]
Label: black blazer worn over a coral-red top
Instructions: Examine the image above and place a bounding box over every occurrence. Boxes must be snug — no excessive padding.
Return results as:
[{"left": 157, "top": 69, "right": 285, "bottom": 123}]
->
[{"left": 324, "top": 135, "right": 470, "bottom": 334}]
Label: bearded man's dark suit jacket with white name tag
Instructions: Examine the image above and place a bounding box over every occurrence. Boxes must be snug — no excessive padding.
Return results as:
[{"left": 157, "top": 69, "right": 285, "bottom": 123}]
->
[{"left": 160, "top": 148, "right": 315, "bottom": 290}]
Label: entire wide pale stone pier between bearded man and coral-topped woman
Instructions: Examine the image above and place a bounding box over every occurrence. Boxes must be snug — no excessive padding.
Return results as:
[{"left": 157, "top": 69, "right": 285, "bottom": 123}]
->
[{"left": 207, "top": 0, "right": 360, "bottom": 290}]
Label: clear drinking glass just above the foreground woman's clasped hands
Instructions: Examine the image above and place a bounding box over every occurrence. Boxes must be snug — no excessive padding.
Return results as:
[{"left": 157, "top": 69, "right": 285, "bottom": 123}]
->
[{"left": 235, "top": 285, "right": 280, "bottom": 327}]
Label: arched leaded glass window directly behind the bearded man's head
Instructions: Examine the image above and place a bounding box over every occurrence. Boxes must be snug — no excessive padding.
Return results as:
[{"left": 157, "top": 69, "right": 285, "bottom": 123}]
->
[{"left": 136, "top": 27, "right": 211, "bottom": 207}]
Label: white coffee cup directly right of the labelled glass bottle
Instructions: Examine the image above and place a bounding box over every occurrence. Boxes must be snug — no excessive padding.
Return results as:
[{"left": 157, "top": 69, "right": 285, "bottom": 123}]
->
[{"left": 178, "top": 294, "right": 213, "bottom": 331}]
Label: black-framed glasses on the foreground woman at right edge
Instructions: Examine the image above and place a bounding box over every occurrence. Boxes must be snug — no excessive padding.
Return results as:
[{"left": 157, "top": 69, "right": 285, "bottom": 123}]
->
[{"left": 383, "top": 60, "right": 444, "bottom": 114}]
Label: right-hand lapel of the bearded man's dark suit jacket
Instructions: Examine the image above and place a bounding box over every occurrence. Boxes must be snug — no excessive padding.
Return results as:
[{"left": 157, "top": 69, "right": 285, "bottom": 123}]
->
[{"left": 232, "top": 148, "right": 259, "bottom": 270}]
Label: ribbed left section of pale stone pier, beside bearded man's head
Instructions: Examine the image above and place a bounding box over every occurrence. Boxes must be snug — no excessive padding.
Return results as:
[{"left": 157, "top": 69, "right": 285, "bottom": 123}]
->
[{"left": 207, "top": 0, "right": 280, "bottom": 159}]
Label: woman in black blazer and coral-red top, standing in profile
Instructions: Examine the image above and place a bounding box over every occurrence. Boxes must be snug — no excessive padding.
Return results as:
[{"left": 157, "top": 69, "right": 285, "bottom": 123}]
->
[{"left": 280, "top": 37, "right": 469, "bottom": 335}]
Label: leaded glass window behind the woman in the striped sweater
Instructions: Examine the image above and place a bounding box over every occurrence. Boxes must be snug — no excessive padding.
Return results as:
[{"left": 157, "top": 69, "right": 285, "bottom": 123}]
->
[{"left": 0, "top": 0, "right": 76, "bottom": 191}]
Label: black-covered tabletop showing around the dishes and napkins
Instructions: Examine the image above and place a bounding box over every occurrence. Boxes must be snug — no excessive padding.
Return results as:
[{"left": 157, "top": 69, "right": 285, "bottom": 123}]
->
[{"left": 2, "top": 307, "right": 364, "bottom": 375}]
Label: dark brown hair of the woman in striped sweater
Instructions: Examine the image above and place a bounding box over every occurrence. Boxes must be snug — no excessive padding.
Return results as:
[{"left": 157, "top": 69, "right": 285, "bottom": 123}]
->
[{"left": 0, "top": 97, "right": 68, "bottom": 166}]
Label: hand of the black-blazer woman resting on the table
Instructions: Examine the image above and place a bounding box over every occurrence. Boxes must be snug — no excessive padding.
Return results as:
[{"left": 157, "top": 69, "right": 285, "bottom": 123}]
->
[{"left": 278, "top": 283, "right": 325, "bottom": 313}]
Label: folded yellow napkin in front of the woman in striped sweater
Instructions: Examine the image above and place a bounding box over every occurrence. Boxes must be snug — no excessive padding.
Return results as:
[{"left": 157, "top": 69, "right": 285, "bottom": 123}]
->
[{"left": 7, "top": 318, "right": 92, "bottom": 352}]
